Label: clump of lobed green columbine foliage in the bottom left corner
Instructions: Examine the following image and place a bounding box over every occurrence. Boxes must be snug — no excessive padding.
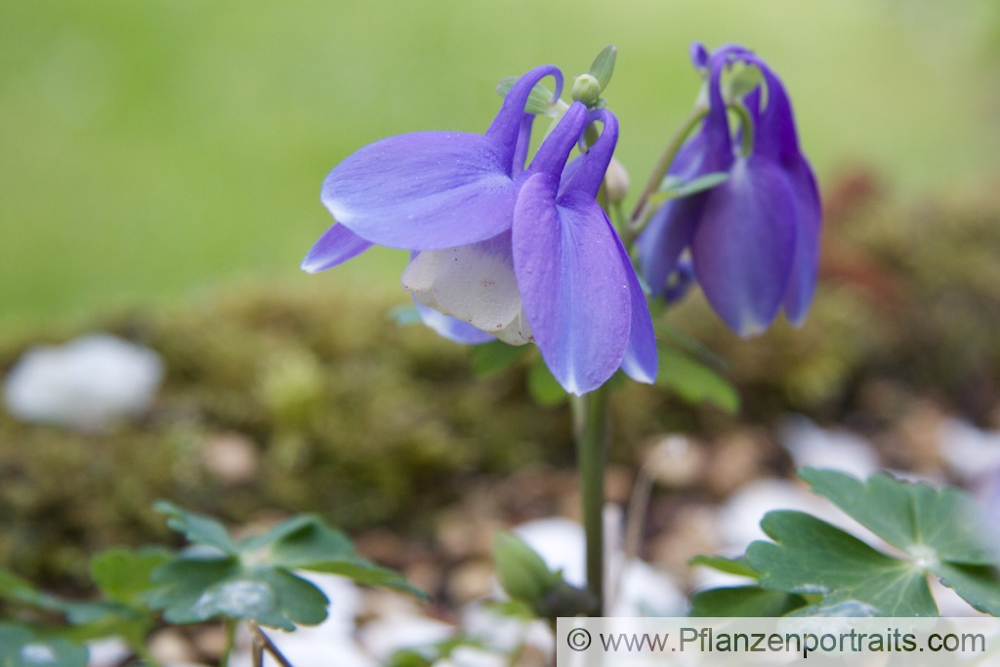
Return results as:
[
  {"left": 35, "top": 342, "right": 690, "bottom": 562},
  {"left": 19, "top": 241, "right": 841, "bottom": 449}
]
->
[{"left": 0, "top": 502, "right": 426, "bottom": 667}]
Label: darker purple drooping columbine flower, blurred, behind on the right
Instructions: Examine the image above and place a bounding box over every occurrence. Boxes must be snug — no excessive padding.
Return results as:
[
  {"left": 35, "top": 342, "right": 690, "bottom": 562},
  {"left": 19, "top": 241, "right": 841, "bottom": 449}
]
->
[{"left": 637, "top": 44, "right": 821, "bottom": 336}]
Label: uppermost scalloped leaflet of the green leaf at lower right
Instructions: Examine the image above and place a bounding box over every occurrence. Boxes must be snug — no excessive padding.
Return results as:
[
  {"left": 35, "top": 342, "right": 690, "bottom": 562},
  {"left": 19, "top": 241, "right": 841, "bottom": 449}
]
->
[{"left": 799, "top": 468, "right": 997, "bottom": 565}]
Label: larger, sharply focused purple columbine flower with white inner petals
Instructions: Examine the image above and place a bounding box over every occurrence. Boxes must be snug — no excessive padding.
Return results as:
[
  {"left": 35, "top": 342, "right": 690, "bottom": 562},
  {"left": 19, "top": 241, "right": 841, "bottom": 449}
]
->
[{"left": 302, "top": 66, "right": 657, "bottom": 394}]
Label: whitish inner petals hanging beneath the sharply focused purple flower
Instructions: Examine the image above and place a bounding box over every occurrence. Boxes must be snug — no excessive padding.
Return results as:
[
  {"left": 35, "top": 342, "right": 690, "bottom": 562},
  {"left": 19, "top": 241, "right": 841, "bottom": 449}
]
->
[{"left": 402, "top": 235, "right": 530, "bottom": 336}]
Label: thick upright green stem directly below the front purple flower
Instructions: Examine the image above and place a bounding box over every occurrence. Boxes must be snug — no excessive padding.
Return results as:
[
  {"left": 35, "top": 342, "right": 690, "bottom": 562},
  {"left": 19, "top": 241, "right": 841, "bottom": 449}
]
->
[{"left": 572, "top": 385, "right": 608, "bottom": 616}]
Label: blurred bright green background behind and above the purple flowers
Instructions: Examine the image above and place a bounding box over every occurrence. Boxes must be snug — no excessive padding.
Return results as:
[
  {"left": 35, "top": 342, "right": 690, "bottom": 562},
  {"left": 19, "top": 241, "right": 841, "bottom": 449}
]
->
[{"left": 0, "top": 0, "right": 1000, "bottom": 328}]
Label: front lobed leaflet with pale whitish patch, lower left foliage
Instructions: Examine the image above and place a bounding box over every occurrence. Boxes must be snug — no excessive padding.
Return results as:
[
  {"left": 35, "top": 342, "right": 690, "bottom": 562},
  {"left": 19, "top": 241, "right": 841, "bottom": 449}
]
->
[{"left": 150, "top": 557, "right": 329, "bottom": 630}]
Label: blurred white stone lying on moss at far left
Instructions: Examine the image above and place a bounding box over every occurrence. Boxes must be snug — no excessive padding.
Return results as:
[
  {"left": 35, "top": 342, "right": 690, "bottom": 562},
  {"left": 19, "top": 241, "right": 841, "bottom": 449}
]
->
[{"left": 4, "top": 334, "right": 164, "bottom": 432}]
